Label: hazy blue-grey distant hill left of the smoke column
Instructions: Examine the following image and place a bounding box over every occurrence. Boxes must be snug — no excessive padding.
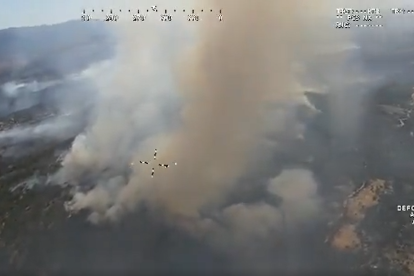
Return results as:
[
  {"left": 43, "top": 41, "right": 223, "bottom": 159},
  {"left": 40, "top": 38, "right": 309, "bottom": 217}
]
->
[{"left": 0, "top": 20, "right": 114, "bottom": 84}]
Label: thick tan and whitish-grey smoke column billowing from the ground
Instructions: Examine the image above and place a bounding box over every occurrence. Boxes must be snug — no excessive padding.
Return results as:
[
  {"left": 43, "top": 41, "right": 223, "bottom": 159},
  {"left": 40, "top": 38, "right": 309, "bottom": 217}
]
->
[{"left": 58, "top": 0, "right": 362, "bottom": 268}]
